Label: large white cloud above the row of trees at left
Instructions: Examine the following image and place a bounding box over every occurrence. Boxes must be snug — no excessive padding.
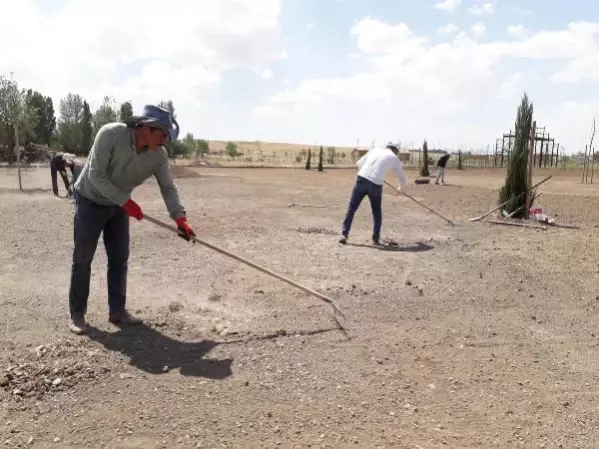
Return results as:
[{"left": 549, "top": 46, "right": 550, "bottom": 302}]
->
[{"left": 0, "top": 0, "right": 286, "bottom": 133}]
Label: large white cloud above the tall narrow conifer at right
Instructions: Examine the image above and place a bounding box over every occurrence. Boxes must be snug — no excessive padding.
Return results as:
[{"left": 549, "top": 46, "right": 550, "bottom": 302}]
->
[{"left": 256, "top": 17, "right": 599, "bottom": 150}]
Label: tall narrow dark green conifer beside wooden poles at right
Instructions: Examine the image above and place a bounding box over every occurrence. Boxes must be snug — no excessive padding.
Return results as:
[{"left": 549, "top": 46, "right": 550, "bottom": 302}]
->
[{"left": 499, "top": 93, "right": 533, "bottom": 218}]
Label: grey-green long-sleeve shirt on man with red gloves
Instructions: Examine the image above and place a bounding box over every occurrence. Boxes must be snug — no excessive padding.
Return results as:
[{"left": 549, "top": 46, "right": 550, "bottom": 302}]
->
[{"left": 75, "top": 123, "right": 186, "bottom": 220}]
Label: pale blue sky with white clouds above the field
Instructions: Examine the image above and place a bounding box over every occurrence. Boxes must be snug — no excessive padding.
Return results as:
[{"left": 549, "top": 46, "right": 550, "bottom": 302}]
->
[{"left": 0, "top": 0, "right": 599, "bottom": 153}]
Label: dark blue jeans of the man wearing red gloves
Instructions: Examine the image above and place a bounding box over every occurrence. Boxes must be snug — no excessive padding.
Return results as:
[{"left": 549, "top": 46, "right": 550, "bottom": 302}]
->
[{"left": 69, "top": 191, "right": 129, "bottom": 315}]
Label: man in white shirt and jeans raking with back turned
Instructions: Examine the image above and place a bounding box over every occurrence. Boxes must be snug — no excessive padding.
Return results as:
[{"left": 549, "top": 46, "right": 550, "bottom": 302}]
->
[{"left": 339, "top": 143, "right": 407, "bottom": 245}]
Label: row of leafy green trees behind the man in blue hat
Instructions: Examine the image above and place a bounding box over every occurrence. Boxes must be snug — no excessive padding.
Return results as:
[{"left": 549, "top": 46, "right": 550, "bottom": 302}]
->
[{"left": 0, "top": 75, "right": 212, "bottom": 164}]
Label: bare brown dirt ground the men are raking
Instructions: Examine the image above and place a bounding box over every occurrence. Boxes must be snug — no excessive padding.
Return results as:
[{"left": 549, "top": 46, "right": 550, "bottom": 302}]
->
[{"left": 0, "top": 168, "right": 599, "bottom": 449}]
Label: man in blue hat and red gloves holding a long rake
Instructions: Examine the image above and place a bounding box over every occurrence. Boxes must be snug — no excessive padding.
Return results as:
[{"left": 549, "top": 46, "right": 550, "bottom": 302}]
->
[{"left": 69, "top": 106, "right": 195, "bottom": 334}]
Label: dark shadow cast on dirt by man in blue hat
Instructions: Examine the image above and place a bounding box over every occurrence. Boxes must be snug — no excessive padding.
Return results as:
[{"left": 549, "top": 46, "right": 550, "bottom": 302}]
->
[{"left": 88, "top": 324, "right": 233, "bottom": 379}]
